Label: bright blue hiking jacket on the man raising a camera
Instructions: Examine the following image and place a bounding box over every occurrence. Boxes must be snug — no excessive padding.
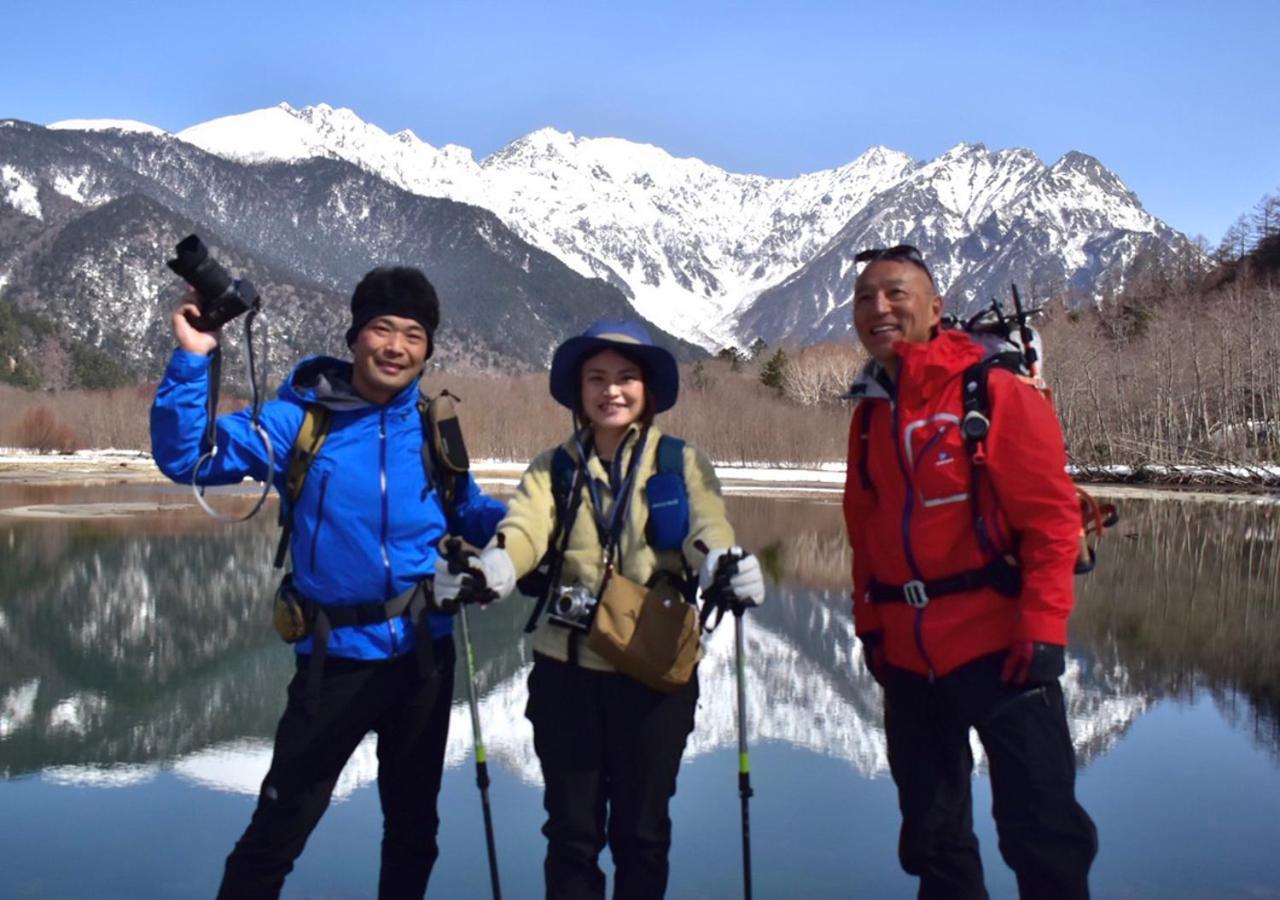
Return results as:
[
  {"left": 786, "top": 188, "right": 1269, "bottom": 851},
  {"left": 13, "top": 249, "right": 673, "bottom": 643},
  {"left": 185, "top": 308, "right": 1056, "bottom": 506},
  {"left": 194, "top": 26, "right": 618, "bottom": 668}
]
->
[{"left": 151, "top": 348, "right": 506, "bottom": 659}]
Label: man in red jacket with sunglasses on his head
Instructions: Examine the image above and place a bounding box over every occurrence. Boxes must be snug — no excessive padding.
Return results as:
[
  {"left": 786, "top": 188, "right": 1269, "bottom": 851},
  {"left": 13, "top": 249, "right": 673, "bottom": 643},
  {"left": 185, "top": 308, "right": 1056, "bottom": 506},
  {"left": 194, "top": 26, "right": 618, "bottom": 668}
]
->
[{"left": 845, "top": 245, "right": 1097, "bottom": 899}]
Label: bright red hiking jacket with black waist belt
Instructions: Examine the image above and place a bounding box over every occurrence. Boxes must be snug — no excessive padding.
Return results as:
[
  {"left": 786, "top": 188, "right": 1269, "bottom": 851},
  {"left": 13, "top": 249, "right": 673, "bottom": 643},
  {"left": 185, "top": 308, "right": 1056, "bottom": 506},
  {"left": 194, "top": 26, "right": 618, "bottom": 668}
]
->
[{"left": 845, "top": 330, "right": 1080, "bottom": 676}]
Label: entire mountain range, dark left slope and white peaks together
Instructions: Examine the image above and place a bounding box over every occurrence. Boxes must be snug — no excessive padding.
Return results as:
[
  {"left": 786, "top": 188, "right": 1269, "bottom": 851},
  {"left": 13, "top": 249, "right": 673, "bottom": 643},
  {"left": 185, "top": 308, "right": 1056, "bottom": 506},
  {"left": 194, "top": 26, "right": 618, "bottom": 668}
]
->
[{"left": 0, "top": 104, "right": 1196, "bottom": 358}]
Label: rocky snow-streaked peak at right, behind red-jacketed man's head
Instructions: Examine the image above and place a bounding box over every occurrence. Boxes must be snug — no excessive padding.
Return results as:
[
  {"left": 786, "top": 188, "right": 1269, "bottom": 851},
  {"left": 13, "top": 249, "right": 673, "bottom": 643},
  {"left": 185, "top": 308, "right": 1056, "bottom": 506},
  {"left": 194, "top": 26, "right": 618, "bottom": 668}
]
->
[{"left": 739, "top": 145, "right": 1197, "bottom": 342}]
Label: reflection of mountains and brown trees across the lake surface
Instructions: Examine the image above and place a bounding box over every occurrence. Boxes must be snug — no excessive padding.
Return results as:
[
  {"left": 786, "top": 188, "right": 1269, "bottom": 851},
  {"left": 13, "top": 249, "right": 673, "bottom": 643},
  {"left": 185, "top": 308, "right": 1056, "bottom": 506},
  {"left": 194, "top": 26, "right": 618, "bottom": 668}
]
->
[{"left": 0, "top": 492, "right": 1280, "bottom": 795}]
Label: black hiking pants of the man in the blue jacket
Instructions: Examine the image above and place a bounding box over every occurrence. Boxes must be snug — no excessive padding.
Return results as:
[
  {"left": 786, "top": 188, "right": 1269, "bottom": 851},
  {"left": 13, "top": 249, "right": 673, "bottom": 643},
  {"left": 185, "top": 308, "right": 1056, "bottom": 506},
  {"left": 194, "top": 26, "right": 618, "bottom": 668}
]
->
[{"left": 218, "top": 638, "right": 456, "bottom": 900}]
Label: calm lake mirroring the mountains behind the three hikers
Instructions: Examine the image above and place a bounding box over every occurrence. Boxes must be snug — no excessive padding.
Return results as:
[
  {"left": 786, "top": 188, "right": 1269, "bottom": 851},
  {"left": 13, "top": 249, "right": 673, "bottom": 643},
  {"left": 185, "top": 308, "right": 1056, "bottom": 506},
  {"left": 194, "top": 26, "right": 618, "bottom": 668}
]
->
[{"left": 0, "top": 485, "right": 1280, "bottom": 900}]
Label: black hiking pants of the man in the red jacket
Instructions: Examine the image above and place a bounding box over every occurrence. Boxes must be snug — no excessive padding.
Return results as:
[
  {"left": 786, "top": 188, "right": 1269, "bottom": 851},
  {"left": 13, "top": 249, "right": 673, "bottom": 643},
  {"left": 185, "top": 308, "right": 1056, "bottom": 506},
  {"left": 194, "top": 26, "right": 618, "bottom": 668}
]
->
[{"left": 884, "top": 654, "right": 1098, "bottom": 900}]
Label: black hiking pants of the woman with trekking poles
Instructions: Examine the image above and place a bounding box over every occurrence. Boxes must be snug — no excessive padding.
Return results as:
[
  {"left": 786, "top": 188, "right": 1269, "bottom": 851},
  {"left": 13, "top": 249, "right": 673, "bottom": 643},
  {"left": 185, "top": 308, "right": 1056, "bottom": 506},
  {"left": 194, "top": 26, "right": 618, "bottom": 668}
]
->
[{"left": 526, "top": 654, "right": 698, "bottom": 900}]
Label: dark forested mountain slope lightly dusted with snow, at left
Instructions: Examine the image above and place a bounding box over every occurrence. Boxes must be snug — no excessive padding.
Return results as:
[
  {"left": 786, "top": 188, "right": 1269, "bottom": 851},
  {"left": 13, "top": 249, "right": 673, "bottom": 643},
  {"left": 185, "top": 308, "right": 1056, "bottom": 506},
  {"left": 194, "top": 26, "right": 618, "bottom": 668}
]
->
[{"left": 0, "top": 120, "right": 700, "bottom": 376}]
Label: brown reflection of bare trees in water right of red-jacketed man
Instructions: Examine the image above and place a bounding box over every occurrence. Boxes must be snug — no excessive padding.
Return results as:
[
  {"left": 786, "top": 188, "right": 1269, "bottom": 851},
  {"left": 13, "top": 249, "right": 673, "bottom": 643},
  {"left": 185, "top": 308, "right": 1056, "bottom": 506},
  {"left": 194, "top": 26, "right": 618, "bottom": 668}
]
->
[{"left": 1071, "top": 502, "right": 1280, "bottom": 762}]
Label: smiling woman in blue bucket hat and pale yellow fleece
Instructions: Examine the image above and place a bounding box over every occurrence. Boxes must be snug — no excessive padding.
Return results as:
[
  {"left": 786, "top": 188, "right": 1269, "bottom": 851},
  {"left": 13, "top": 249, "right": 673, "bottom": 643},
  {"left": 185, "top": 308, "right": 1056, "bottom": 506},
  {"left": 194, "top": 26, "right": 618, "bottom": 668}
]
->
[{"left": 435, "top": 321, "right": 764, "bottom": 900}]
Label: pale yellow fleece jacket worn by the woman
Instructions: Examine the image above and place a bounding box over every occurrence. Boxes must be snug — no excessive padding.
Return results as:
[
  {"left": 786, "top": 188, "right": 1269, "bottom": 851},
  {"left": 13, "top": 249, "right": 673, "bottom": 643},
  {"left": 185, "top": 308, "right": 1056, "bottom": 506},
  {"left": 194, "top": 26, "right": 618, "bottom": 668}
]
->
[{"left": 490, "top": 425, "right": 733, "bottom": 672}]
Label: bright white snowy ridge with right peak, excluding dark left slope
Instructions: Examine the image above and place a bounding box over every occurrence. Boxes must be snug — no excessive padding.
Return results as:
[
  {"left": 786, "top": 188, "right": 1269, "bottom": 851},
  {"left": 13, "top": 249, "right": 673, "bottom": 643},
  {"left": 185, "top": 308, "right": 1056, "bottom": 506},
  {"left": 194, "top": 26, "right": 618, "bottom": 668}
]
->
[{"left": 178, "top": 104, "right": 1188, "bottom": 350}]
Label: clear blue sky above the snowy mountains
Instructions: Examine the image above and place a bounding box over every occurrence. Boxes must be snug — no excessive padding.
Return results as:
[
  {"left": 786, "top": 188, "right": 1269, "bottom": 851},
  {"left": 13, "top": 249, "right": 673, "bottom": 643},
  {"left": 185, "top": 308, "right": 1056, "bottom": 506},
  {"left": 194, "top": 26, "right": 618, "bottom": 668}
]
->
[{"left": 0, "top": 0, "right": 1280, "bottom": 243}]
